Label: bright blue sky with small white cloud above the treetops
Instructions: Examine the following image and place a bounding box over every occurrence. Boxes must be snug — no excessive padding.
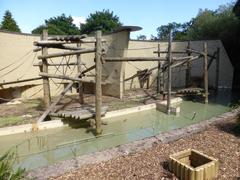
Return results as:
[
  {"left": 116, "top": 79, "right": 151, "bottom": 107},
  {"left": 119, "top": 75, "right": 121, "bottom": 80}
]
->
[{"left": 0, "top": 0, "right": 235, "bottom": 38}]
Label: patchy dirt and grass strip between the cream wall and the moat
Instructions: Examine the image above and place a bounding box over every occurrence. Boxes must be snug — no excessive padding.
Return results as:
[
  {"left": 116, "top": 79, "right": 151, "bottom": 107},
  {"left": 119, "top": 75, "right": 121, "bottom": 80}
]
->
[{"left": 0, "top": 89, "right": 159, "bottom": 127}]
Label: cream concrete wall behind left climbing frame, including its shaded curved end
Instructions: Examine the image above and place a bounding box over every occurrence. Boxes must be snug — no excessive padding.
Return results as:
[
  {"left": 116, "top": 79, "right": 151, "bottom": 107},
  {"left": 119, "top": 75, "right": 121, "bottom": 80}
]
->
[{"left": 0, "top": 30, "right": 129, "bottom": 98}]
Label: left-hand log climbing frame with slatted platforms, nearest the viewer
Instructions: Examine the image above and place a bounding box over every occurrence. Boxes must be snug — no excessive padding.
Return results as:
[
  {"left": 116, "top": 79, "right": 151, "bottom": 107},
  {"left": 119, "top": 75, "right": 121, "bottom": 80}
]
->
[{"left": 34, "top": 30, "right": 106, "bottom": 134}]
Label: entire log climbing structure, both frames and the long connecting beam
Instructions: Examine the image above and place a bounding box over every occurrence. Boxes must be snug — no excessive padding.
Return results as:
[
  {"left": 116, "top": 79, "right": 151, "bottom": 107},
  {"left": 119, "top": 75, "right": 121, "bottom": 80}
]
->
[{"left": 34, "top": 31, "right": 220, "bottom": 134}]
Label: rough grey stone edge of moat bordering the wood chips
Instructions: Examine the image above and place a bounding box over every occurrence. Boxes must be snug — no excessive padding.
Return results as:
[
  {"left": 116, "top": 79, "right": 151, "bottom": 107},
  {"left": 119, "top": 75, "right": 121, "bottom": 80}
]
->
[{"left": 27, "top": 108, "right": 240, "bottom": 179}]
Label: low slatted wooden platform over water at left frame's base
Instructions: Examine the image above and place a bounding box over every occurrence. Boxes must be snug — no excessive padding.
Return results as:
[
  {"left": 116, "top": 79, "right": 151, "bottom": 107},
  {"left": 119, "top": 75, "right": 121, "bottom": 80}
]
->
[{"left": 50, "top": 106, "right": 108, "bottom": 120}]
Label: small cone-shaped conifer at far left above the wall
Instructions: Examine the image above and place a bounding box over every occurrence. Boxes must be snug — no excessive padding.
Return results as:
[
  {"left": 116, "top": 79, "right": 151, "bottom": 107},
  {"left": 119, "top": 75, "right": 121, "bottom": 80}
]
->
[{"left": 0, "top": 10, "right": 21, "bottom": 32}]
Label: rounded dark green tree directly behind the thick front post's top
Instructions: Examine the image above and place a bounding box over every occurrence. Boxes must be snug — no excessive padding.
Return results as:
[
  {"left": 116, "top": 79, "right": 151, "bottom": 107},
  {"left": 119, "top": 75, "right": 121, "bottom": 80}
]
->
[{"left": 81, "top": 10, "right": 122, "bottom": 34}]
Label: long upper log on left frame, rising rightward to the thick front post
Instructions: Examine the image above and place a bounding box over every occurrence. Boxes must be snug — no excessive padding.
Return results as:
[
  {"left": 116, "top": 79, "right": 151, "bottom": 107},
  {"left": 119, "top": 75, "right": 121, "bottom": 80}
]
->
[{"left": 38, "top": 48, "right": 95, "bottom": 59}]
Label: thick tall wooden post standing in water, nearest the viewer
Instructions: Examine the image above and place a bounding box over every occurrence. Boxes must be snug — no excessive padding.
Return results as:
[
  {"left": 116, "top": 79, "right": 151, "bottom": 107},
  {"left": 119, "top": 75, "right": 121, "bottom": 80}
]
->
[{"left": 95, "top": 30, "right": 102, "bottom": 135}]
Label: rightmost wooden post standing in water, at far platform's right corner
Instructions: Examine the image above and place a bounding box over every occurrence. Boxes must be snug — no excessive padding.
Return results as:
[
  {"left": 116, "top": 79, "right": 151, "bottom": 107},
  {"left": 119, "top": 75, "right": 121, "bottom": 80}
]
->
[{"left": 203, "top": 42, "right": 208, "bottom": 104}]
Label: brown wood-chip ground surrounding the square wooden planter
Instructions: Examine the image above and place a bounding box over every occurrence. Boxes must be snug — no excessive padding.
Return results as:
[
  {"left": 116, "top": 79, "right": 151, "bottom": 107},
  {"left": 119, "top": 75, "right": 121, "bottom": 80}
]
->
[{"left": 52, "top": 119, "right": 240, "bottom": 180}]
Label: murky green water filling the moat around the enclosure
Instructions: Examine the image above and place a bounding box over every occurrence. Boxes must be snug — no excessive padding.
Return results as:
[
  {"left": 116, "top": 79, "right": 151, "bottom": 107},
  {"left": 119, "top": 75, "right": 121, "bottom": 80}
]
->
[{"left": 0, "top": 92, "right": 236, "bottom": 170}]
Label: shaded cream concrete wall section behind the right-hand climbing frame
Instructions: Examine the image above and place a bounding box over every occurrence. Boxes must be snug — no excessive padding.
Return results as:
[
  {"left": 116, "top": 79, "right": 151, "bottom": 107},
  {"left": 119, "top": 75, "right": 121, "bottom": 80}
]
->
[{"left": 125, "top": 40, "right": 233, "bottom": 89}]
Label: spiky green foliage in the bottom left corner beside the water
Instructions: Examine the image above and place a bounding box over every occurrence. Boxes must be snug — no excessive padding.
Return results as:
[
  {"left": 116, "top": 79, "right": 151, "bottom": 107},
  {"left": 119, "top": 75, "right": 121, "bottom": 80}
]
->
[{"left": 0, "top": 152, "right": 25, "bottom": 180}]
